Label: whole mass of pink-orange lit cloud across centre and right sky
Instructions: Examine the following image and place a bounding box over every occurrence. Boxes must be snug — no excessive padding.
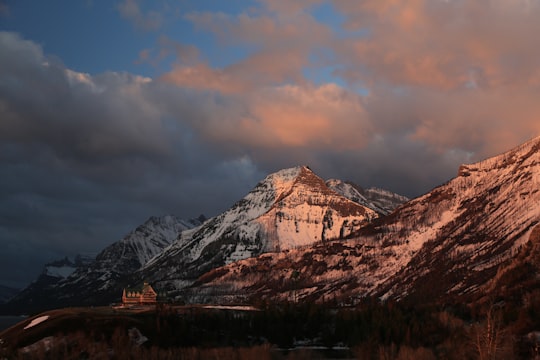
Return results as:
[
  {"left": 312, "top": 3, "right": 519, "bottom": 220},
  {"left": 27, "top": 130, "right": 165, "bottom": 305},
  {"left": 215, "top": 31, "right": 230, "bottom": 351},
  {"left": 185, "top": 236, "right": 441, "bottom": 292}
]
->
[{"left": 161, "top": 0, "right": 540, "bottom": 179}]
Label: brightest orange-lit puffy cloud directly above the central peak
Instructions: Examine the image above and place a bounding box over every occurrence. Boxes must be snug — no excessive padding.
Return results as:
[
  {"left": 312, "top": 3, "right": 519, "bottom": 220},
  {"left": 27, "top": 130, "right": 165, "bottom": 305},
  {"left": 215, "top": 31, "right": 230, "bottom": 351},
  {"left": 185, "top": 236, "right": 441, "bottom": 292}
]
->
[{"left": 213, "top": 84, "right": 370, "bottom": 152}]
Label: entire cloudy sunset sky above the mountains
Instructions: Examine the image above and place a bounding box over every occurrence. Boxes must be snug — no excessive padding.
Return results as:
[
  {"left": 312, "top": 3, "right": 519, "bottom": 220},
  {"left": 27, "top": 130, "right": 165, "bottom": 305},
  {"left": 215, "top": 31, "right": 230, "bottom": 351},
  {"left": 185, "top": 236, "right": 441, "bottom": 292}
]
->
[{"left": 0, "top": 0, "right": 540, "bottom": 287}]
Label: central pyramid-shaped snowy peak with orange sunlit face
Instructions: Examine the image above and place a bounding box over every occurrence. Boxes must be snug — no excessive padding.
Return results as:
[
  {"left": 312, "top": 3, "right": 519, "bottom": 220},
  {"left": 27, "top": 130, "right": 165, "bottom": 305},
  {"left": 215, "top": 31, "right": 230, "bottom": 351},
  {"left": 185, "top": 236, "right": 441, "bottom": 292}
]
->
[{"left": 140, "top": 166, "right": 378, "bottom": 291}]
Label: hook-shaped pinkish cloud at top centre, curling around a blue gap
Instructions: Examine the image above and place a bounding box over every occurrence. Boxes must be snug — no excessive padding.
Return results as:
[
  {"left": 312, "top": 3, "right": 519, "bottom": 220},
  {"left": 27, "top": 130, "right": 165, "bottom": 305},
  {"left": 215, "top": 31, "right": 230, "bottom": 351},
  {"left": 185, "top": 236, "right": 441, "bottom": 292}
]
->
[{"left": 169, "top": 2, "right": 332, "bottom": 93}]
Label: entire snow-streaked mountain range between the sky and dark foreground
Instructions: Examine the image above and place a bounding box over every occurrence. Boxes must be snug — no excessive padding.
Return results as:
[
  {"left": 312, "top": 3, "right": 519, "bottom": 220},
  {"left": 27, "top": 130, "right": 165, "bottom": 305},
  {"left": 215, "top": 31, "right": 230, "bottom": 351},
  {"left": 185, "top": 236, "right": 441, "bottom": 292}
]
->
[{"left": 8, "top": 137, "right": 540, "bottom": 309}]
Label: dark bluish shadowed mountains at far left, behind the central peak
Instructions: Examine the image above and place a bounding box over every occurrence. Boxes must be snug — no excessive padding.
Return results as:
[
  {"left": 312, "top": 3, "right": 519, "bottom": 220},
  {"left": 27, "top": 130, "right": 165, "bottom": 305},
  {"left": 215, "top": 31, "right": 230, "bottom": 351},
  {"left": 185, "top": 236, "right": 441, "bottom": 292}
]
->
[{"left": 6, "top": 215, "right": 205, "bottom": 308}]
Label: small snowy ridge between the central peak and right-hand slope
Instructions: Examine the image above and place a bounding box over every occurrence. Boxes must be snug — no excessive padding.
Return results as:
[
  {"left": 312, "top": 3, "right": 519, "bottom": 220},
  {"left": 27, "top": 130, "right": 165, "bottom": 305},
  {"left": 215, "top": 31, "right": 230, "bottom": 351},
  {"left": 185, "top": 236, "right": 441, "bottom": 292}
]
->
[{"left": 326, "top": 179, "right": 409, "bottom": 215}]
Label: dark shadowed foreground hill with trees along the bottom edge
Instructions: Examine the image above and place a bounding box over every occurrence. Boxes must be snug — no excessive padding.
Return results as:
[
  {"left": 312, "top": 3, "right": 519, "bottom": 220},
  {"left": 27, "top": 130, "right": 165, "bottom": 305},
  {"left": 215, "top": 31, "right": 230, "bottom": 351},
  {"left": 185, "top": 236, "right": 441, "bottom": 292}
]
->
[{"left": 0, "top": 301, "right": 540, "bottom": 360}]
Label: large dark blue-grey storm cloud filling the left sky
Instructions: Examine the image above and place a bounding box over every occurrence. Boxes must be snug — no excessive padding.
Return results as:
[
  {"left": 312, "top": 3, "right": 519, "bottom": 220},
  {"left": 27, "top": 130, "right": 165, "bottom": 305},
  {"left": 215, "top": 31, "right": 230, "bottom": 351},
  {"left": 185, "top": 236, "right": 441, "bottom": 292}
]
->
[{"left": 0, "top": 33, "right": 261, "bottom": 285}]
